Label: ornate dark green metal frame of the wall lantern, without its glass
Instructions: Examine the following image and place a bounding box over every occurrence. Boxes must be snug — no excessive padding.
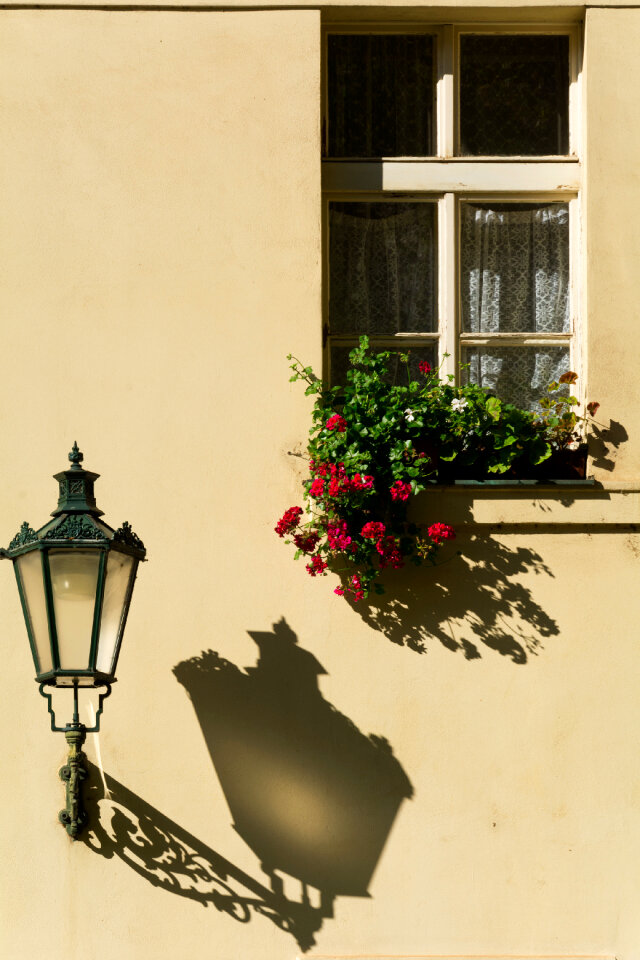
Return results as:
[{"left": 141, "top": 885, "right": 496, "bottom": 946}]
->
[{"left": 0, "top": 443, "right": 146, "bottom": 839}]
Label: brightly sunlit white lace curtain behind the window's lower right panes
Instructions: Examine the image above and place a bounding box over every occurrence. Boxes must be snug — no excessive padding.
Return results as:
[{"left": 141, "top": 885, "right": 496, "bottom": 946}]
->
[{"left": 461, "top": 203, "right": 570, "bottom": 409}]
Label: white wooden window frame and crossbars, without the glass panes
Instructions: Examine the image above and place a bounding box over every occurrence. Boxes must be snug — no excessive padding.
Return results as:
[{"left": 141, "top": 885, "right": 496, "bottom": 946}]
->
[{"left": 322, "top": 23, "right": 586, "bottom": 394}]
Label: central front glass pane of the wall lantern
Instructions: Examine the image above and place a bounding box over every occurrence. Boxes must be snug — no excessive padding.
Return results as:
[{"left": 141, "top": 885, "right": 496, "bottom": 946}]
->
[{"left": 49, "top": 550, "right": 100, "bottom": 670}]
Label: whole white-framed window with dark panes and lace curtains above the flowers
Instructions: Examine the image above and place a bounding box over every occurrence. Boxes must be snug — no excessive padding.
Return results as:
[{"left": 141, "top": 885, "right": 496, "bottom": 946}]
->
[{"left": 323, "top": 25, "right": 581, "bottom": 407}]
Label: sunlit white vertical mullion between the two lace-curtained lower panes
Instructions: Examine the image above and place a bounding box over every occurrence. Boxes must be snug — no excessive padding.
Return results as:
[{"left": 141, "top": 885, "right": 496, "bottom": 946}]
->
[{"left": 438, "top": 193, "right": 458, "bottom": 376}]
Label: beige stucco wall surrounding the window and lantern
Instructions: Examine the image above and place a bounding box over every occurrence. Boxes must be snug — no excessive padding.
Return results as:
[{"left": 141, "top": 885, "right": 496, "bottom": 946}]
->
[{"left": 0, "top": 5, "right": 640, "bottom": 960}]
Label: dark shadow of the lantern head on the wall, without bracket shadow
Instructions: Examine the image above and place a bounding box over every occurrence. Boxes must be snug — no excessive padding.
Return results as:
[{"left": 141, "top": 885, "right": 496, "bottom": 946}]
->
[{"left": 174, "top": 620, "right": 413, "bottom": 915}]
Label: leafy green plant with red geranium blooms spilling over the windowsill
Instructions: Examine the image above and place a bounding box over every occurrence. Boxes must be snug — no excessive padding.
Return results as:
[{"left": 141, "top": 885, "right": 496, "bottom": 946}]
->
[{"left": 276, "top": 337, "right": 597, "bottom": 600}]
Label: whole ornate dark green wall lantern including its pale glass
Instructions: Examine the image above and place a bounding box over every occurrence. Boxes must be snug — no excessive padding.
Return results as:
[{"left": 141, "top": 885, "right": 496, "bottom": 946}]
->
[{"left": 1, "top": 443, "right": 146, "bottom": 839}]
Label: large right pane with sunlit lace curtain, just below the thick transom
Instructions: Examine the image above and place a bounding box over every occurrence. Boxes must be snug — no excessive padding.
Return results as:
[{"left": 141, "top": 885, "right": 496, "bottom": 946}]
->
[{"left": 460, "top": 203, "right": 570, "bottom": 333}]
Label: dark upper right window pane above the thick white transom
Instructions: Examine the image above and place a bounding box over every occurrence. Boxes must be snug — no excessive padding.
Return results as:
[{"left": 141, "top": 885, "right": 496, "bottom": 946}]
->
[{"left": 460, "top": 36, "right": 569, "bottom": 157}]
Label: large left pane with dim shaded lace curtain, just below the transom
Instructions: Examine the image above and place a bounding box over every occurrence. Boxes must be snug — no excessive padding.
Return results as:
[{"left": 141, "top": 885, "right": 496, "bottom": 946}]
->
[{"left": 329, "top": 202, "right": 436, "bottom": 336}]
